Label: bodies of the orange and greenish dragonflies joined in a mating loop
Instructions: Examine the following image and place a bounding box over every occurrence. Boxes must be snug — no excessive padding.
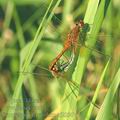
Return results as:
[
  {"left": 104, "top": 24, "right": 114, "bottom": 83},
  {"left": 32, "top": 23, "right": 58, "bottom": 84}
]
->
[{"left": 49, "top": 20, "right": 84, "bottom": 75}]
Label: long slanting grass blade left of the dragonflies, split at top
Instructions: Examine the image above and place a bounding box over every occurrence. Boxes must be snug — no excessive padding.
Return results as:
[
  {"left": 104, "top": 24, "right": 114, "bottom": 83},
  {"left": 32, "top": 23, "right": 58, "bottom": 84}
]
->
[{"left": 6, "top": 0, "right": 61, "bottom": 120}]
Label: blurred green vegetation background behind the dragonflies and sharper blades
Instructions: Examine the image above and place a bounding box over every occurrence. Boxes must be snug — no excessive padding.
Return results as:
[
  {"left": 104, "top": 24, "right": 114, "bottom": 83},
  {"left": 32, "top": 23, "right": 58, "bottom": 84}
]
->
[{"left": 0, "top": 0, "right": 120, "bottom": 120}]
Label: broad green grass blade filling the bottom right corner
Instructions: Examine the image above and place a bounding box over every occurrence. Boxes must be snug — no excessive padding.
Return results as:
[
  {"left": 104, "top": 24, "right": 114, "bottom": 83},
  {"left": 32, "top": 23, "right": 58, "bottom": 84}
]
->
[{"left": 96, "top": 68, "right": 120, "bottom": 120}]
